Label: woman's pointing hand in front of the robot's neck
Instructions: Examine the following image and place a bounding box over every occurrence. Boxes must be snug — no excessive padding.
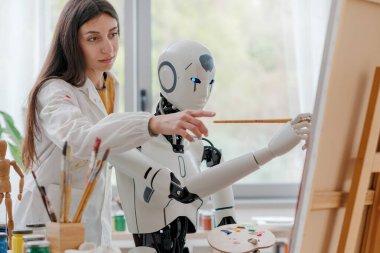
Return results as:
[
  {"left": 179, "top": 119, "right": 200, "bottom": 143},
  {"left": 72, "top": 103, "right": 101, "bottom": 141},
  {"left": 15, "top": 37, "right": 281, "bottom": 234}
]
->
[{"left": 148, "top": 110, "right": 215, "bottom": 141}]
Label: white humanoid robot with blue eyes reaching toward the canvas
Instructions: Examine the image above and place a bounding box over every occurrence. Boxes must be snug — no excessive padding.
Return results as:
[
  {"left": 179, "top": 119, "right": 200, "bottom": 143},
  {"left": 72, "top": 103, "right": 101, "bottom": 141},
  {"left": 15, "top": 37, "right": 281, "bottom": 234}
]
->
[{"left": 116, "top": 41, "right": 311, "bottom": 253}]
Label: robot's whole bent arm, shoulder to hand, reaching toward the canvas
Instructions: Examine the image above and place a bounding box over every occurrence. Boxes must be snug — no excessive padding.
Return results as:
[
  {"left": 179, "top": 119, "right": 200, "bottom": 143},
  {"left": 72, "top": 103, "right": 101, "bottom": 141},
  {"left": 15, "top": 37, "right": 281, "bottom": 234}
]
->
[{"left": 114, "top": 114, "right": 311, "bottom": 203}]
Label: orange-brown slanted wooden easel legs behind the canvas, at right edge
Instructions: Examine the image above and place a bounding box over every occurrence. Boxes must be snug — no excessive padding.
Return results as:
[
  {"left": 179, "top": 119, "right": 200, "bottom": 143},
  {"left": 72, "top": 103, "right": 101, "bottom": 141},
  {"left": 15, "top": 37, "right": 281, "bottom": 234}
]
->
[{"left": 338, "top": 67, "right": 380, "bottom": 253}]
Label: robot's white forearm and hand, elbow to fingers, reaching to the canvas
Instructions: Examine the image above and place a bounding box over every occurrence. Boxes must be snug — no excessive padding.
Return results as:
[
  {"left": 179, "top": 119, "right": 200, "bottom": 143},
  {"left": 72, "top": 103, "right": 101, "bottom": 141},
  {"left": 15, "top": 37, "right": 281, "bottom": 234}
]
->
[{"left": 185, "top": 114, "right": 311, "bottom": 198}]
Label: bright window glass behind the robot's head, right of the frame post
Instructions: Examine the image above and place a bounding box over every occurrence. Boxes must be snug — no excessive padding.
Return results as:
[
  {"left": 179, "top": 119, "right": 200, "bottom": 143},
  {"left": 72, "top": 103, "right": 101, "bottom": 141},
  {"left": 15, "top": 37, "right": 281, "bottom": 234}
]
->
[{"left": 145, "top": 0, "right": 329, "bottom": 188}]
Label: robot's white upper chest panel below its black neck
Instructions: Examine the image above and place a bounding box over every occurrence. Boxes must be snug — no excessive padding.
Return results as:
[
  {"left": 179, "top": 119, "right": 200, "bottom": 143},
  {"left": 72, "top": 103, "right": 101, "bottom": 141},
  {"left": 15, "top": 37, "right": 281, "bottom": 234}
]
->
[{"left": 141, "top": 136, "right": 203, "bottom": 179}]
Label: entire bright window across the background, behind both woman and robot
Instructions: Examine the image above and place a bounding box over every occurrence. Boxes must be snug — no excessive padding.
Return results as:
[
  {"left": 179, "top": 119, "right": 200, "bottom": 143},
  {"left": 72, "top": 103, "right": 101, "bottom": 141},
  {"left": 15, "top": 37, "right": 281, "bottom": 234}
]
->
[{"left": 0, "top": 0, "right": 331, "bottom": 219}]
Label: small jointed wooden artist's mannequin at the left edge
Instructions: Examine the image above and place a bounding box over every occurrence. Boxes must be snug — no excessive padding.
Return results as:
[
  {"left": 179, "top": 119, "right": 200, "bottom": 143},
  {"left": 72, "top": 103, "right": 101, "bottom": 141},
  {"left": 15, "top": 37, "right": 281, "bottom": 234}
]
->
[{"left": 0, "top": 140, "right": 24, "bottom": 249}]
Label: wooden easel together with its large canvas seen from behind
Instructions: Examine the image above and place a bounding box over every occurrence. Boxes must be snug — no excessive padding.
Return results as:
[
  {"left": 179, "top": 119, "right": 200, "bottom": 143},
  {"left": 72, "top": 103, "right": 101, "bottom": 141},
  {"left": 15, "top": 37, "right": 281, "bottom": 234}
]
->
[{"left": 290, "top": 0, "right": 380, "bottom": 253}]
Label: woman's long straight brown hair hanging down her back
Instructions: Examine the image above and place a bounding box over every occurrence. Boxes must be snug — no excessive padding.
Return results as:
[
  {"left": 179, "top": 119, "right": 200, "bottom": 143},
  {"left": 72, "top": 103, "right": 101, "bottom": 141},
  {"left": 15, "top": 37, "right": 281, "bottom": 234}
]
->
[{"left": 22, "top": 0, "right": 119, "bottom": 169}]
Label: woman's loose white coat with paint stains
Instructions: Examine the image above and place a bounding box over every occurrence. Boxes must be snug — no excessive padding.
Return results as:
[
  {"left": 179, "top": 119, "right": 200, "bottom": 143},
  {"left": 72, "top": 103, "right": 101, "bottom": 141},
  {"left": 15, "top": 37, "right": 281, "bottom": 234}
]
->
[{"left": 14, "top": 73, "right": 152, "bottom": 245}]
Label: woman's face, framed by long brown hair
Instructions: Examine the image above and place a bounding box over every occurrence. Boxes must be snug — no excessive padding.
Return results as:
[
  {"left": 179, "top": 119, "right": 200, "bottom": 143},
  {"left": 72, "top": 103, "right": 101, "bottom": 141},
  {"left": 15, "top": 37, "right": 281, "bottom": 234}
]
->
[{"left": 79, "top": 14, "right": 119, "bottom": 75}]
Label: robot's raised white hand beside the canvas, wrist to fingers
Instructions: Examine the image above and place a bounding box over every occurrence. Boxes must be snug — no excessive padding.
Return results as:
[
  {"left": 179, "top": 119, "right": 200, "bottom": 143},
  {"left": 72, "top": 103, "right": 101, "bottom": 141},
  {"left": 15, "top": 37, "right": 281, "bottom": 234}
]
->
[{"left": 268, "top": 113, "right": 311, "bottom": 156}]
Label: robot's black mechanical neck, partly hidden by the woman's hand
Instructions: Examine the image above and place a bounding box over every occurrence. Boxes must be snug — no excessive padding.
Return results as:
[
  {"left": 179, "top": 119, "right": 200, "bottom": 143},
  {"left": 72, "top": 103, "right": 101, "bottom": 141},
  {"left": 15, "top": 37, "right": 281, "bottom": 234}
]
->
[{"left": 154, "top": 94, "right": 183, "bottom": 153}]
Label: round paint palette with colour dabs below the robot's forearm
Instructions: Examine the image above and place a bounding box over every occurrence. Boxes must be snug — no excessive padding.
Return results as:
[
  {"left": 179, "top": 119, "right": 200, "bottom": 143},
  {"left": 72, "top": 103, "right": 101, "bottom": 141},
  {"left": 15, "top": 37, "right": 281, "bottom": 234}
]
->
[{"left": 208, "top": 224, "right": 276, "bottom": 253}]
